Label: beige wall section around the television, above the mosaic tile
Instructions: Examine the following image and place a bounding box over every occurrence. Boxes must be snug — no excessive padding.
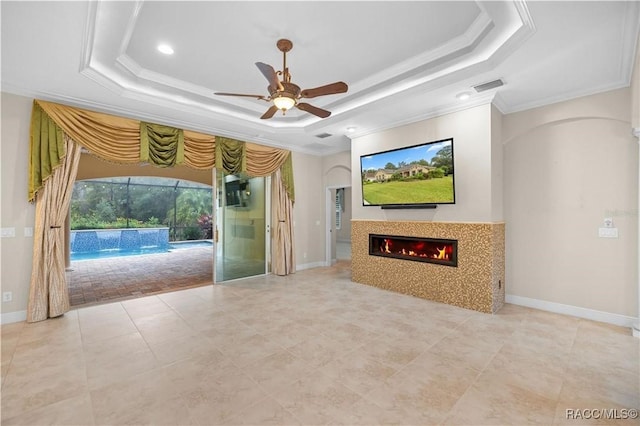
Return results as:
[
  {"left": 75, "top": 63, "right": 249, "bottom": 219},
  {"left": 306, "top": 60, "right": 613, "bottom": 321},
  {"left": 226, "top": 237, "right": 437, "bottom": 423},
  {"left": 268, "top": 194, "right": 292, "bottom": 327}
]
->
[{"left": 351, "top": 104, "right": 502, "bottom": 222}]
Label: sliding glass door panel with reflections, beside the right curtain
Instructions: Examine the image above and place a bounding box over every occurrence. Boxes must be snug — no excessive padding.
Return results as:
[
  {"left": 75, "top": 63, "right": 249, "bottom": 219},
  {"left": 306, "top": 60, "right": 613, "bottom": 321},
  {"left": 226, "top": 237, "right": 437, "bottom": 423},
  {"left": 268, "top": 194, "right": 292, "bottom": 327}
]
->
[{"left": 215, "top": 172, "right": 270, "bottom": 282}]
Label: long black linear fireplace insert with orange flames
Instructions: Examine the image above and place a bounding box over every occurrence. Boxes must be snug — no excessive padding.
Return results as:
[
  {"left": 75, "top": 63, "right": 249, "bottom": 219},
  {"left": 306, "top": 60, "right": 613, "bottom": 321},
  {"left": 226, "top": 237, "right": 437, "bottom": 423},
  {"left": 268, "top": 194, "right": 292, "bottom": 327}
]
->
[{"left": 369, "top": 234, "right": 458, "bottom": 267}]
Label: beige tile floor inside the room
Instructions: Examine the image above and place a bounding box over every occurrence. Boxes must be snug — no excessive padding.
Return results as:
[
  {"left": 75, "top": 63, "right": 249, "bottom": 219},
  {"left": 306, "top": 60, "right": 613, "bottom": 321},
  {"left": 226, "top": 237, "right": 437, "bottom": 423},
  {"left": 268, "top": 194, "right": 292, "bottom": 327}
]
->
[{"left": 1, "top": 262, "right": 640, "bottom": 426}]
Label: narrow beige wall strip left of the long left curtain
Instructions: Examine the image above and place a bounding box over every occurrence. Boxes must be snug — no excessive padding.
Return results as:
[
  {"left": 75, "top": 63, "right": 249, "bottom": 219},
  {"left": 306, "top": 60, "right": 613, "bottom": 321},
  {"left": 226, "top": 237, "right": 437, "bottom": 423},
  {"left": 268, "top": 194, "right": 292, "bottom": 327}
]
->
[{"left": 0, "top": 93, "right": 35, "bottom": 321}]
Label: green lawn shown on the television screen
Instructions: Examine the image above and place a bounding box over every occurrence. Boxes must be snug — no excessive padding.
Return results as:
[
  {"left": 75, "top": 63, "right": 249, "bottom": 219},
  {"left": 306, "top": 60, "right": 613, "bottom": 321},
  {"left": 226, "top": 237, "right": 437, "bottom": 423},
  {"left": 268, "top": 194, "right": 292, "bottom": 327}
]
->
[{"left": 362, "top": 175, "right": 453, "bottom": 204}]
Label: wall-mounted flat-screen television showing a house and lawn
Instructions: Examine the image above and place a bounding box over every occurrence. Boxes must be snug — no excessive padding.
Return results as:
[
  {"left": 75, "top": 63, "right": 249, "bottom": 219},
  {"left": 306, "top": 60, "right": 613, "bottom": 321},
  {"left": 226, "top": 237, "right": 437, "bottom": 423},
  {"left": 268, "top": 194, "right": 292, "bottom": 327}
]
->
[{"left": 360, "top": 138, "right": 456, "bottom": 208}]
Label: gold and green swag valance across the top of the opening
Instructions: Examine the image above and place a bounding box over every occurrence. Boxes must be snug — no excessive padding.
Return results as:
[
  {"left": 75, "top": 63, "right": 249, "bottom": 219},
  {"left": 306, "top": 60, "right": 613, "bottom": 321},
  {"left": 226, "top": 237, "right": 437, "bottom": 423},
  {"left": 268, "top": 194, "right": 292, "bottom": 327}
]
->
[{"left": 29, "top": 100, "right": 294, "bottom": 201}]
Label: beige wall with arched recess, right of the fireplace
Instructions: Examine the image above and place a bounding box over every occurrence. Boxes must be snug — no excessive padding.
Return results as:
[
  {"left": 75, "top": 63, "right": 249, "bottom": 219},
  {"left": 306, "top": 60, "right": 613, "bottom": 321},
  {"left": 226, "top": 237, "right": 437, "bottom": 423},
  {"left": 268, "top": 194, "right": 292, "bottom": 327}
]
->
[{"left": 503, "top": 89, "right": 638, "bottom": 317}]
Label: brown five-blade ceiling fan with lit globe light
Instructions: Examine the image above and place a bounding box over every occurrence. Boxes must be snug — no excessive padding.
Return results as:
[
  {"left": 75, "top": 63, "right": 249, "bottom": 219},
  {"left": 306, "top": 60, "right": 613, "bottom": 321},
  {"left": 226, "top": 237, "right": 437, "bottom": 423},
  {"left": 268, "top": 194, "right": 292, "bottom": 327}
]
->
[{"left": 215, "top": 38, "right": 349, "bottom": 119}]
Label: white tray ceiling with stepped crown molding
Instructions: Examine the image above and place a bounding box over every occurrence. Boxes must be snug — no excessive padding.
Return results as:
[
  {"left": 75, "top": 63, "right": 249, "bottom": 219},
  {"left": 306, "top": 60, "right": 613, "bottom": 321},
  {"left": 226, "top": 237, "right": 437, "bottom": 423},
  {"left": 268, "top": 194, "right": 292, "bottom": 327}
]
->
[{"left": 0, "top": 1, "right": 640, "bottom": 155}]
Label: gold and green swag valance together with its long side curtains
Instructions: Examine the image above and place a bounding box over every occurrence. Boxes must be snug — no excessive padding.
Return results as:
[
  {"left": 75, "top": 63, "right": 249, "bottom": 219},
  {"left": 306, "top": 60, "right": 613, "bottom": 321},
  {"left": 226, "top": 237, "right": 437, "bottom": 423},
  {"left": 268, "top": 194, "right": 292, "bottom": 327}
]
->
[{"left": 27, "top": 100, "right": 295, "bottom": 322}]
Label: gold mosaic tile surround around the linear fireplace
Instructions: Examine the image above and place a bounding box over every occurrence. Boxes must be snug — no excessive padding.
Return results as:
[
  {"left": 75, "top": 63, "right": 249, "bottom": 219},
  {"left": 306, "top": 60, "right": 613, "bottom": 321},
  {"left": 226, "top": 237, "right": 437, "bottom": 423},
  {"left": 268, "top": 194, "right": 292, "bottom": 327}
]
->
[{"left": 351, "top": 220, "right": 505, "bottom": 313}]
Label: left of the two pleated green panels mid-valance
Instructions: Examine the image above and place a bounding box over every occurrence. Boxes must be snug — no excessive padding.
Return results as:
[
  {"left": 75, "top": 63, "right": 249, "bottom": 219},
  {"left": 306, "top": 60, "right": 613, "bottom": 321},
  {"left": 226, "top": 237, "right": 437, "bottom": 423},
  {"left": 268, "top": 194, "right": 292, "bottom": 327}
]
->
[{"left": 140, "top": 122, "right": 184, "bottom": 167}]
